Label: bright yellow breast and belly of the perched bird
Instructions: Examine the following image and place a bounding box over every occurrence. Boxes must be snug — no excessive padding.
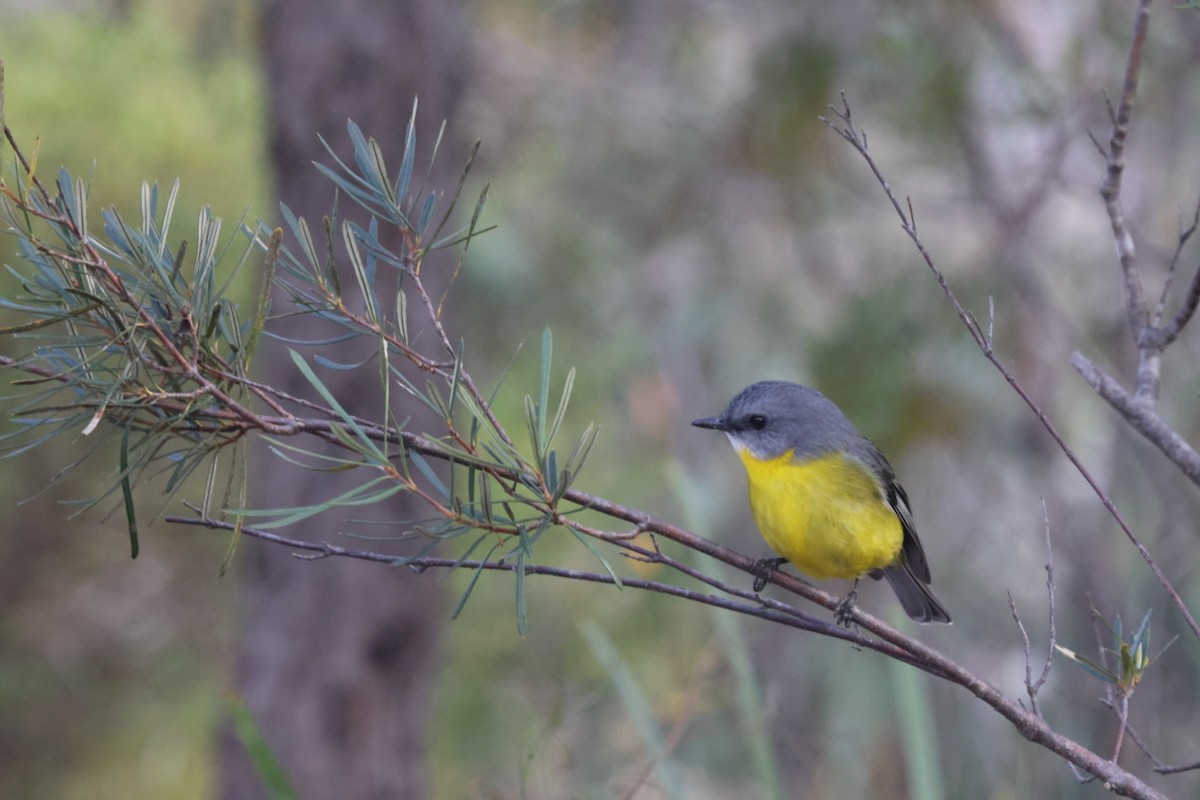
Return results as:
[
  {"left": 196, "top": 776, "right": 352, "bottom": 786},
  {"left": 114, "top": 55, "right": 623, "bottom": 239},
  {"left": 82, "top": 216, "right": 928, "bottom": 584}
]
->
[{"left": 738, "top": 449, "right": 904, "bottom": 578}]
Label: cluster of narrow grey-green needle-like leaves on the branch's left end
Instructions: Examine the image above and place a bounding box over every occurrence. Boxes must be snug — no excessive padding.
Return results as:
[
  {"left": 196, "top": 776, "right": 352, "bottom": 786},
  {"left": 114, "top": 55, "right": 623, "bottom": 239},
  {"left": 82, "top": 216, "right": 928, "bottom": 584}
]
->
[{"left": 0, "top": 106, "right": 600, "bottom": 631}]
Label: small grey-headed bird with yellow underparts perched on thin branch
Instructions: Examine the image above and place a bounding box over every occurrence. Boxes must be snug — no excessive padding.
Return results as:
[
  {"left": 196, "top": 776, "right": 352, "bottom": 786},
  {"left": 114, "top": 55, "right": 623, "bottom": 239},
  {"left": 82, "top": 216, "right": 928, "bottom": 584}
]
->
[{"left": 692, "top": 380, "right": 950, "bottom": 624}]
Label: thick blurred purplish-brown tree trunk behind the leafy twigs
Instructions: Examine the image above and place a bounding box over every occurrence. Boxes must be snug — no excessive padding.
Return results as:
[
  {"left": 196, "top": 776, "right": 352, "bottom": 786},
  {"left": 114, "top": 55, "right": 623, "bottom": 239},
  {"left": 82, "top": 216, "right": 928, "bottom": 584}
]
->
[{"left": 221, "top": 0, "right": 469, "bottom": 800}]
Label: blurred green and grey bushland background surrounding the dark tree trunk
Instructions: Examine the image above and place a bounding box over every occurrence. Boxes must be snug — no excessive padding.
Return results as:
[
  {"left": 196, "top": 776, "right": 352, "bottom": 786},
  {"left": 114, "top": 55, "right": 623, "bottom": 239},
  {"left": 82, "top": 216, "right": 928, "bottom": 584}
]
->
[{"left": 0, "top": 0, "right": 1200, "bottom": 799}]
